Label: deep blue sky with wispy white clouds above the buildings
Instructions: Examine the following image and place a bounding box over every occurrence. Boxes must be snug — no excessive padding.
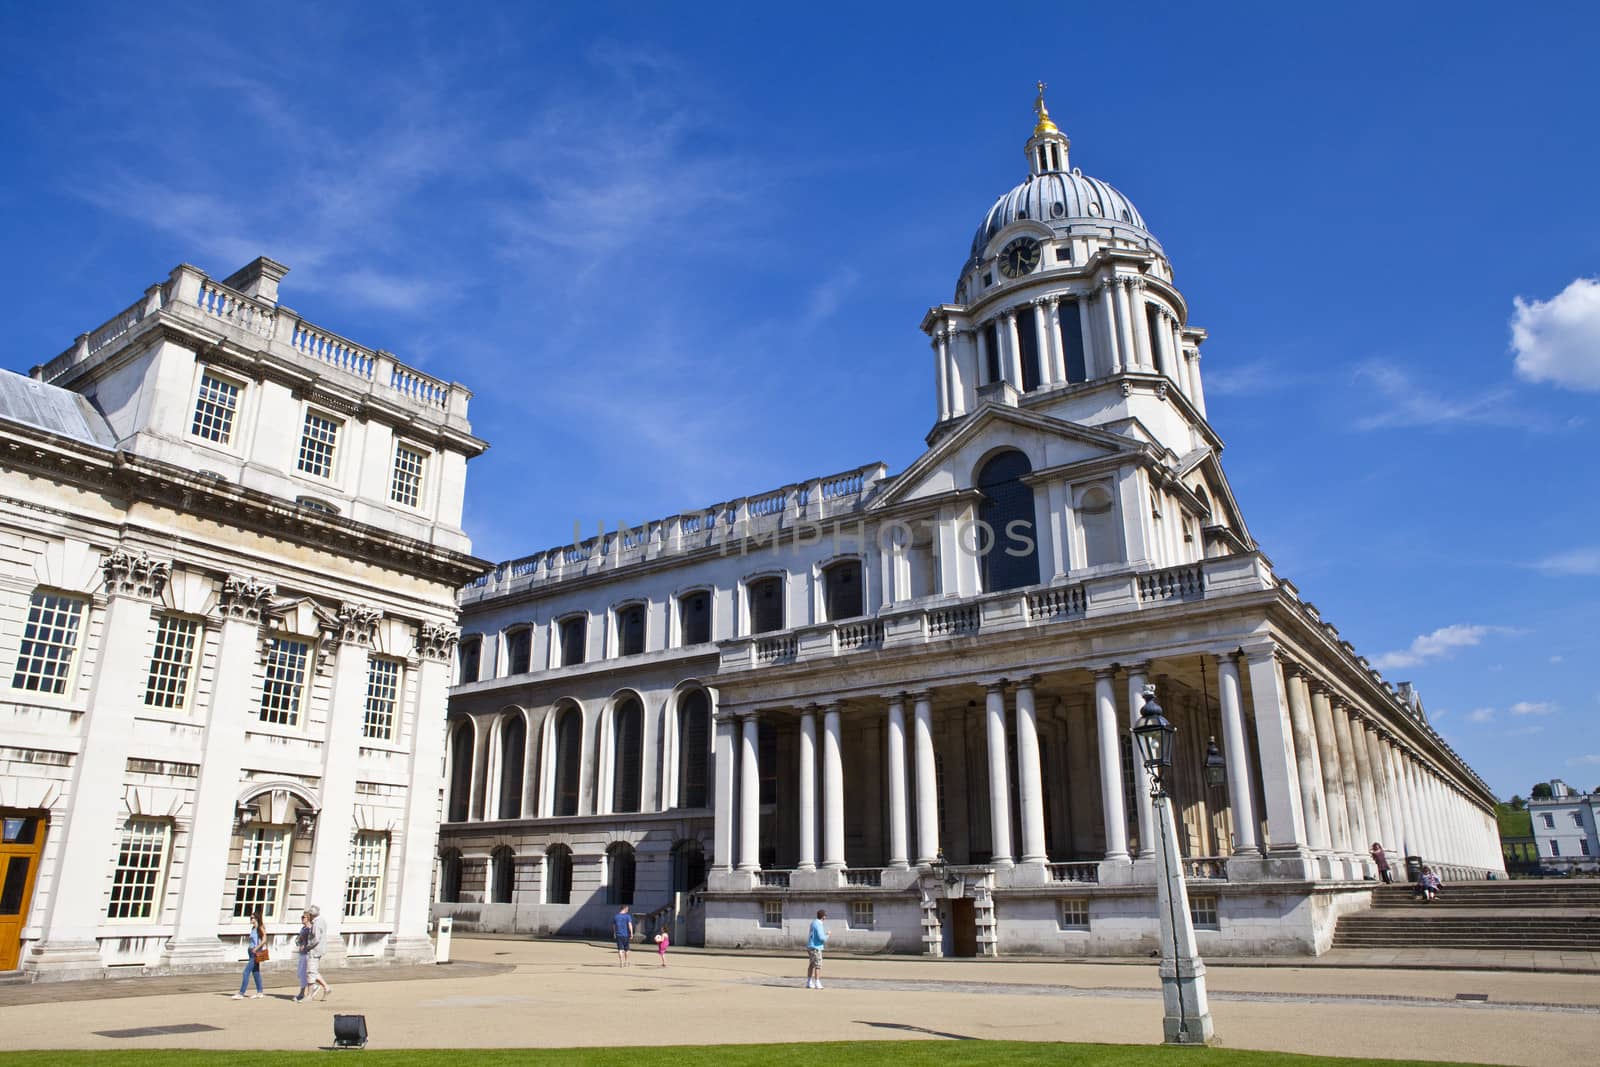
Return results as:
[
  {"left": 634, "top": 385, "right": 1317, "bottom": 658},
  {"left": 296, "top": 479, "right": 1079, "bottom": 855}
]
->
[{"left": 0, "top": 2, "right": 1600, "bottom": 795}]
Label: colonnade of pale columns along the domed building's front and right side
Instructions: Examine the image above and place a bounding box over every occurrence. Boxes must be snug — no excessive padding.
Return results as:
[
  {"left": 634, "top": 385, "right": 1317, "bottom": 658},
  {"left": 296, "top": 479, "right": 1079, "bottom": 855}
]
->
[{"left": 714, "top": 646, "right": 1502, "bottom": 880}]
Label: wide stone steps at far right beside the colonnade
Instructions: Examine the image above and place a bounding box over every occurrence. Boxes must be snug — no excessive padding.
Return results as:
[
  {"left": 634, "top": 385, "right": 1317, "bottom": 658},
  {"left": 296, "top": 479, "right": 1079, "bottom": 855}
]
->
[{"left": 1333, "top": 878, "right": 1600, "bottom": 952}]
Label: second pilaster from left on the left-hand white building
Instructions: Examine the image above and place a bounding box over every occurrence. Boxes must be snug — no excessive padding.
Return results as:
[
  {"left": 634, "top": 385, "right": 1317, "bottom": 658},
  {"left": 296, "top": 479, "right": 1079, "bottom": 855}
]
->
[{"left": 162, "top": 577, "right": 275, "bottom": 969}]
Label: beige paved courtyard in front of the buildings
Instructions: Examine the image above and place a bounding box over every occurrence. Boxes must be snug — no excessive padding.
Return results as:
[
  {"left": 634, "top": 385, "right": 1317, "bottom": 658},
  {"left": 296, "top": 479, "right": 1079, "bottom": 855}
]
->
[{"left": 0, "top": 937, "right": 1600, "bottom": 1067}]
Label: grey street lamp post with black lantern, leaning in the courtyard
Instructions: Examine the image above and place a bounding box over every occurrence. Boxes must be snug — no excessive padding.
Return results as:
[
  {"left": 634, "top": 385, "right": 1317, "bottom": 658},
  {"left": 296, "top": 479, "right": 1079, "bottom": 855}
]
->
[{"left": 1133, "top": 685, "right": 1213, "bottom": 1045}]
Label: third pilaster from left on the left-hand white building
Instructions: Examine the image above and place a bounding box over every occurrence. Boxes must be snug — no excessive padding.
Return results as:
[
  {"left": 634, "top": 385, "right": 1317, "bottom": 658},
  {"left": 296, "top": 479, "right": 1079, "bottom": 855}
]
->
[{"left": 306, "top": 603, "right": 382, "bottom": 961}]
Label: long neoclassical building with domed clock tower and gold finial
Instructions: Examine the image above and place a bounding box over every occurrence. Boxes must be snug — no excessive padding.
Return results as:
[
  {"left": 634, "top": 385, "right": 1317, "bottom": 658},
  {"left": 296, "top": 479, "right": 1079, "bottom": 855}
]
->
[{"left": 438, "top": 96, "right": 1502, "bottom": 955}]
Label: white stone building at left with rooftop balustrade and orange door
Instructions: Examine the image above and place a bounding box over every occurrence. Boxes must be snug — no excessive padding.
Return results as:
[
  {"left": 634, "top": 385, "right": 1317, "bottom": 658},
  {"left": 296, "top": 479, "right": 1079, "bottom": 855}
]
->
[{"left": 0, "top": 259, "right": 485, "bottom": 979}]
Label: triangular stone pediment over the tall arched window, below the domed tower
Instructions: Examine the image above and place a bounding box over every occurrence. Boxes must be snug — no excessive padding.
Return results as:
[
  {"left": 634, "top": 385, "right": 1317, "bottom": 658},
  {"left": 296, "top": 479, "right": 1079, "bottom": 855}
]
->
[{"left": 872, "top": 405, "right": 1147, "bottom": 509}]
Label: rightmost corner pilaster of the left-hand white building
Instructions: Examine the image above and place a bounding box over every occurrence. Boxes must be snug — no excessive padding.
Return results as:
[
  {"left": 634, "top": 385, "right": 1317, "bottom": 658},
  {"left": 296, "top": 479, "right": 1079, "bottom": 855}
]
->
[{"left": 389, "top": 622, "right": 459, "bottom": 961}]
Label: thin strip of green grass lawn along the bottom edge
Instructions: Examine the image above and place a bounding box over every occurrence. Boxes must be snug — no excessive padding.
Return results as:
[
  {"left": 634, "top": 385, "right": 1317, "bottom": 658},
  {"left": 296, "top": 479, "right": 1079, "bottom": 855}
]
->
[{"left": 0, "top": 1041, "right": 1484, "bottom": 1067}]
